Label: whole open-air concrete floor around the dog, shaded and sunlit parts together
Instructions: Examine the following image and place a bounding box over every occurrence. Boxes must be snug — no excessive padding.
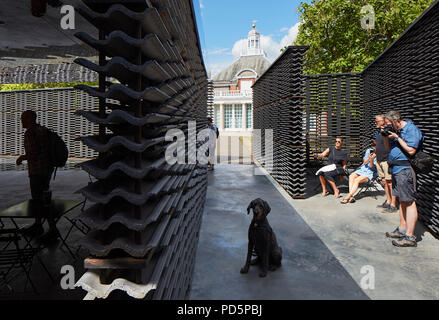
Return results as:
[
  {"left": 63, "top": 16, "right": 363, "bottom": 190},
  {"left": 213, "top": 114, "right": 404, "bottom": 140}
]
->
[{"left": 191, "top": 165, "right": 439, "bottom": 299}]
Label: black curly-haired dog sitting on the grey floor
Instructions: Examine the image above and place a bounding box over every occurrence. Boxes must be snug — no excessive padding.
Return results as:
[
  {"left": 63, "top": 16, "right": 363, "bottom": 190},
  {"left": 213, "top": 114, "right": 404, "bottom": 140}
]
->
[{"left": 241, "top": 198, "right": 282, "bottom": 277}]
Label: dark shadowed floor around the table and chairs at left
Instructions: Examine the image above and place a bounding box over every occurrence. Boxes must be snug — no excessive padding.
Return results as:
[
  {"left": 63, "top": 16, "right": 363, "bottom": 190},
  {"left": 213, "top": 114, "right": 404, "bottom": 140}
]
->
[{"left": 0, "top": 169, "right": 89, "bottom": 300}]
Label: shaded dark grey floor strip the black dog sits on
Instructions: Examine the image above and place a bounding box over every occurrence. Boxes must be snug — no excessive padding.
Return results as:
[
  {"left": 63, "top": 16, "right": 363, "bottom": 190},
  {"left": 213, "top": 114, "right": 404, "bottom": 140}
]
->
[{"left": 191, "top": 164, "right": 368, "bottom": 299}]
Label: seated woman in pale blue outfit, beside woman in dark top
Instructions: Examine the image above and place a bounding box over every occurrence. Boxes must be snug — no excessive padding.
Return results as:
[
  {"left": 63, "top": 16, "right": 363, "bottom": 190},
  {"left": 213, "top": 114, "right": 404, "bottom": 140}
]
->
[{"left": 340, "top": 140, "right": 378, "bottom": 203}]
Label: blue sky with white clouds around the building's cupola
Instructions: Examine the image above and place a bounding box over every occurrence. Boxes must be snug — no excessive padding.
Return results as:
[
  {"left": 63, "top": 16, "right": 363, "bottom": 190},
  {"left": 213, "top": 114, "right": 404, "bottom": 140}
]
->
[{"left": 194, "top": 0, "right": 309, "bottom": 76}]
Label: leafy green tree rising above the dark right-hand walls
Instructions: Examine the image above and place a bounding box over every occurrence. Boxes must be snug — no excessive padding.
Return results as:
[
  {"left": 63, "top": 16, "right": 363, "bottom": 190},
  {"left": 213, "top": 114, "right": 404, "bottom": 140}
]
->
[{"left": 294, "top": 0, "right": 434, "bottom": 74}]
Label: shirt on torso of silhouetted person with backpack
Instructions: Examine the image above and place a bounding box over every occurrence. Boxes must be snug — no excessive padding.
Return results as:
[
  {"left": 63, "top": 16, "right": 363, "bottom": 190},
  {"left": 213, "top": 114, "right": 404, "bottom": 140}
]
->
[{"left": 24, "top": 124, "right": 52, "bottom": 176}]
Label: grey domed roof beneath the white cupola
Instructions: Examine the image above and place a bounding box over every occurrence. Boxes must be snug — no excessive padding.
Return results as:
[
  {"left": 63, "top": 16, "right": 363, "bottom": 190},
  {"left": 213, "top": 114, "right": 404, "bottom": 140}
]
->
[{"left": 213, "top": 55, "right": 270, "bottom": 81}]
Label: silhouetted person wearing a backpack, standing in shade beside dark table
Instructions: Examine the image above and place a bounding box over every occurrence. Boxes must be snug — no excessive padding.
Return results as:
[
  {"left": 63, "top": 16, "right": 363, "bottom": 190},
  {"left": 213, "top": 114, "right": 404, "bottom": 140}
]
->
[{"left": 16, "top": 110, "right": 59, "bottom": 239}]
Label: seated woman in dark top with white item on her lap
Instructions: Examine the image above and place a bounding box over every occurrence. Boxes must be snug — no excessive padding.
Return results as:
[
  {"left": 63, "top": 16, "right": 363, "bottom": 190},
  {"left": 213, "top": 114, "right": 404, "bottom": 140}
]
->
[{"left": 316, "top": 137, "right": 348, "bottom": 198}]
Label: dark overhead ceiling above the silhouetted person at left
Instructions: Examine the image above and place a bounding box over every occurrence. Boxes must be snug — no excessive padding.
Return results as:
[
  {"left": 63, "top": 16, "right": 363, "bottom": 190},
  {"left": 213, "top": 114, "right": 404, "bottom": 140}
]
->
[{"left": 0, "top": 0, "right": 98, "bottom": 70}]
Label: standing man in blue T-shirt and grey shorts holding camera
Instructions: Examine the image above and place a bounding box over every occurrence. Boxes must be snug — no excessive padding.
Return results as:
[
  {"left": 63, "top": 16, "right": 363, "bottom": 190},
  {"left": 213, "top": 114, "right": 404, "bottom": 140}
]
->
[{"left": 381, "top": 110, "right": 424, "bottom": 247}]
